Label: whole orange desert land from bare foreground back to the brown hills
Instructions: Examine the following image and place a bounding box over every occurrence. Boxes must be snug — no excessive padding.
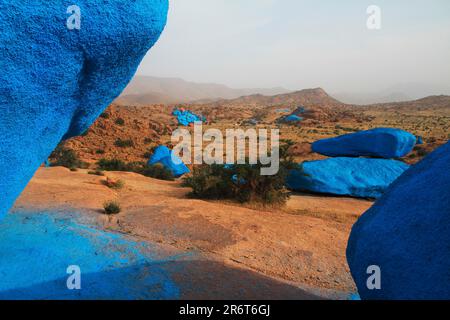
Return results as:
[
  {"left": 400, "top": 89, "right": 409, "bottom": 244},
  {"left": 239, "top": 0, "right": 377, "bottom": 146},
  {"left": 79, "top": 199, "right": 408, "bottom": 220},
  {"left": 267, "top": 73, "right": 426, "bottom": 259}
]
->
[{"left": 8, "top": 84, "right": 450, "bottom": 299}]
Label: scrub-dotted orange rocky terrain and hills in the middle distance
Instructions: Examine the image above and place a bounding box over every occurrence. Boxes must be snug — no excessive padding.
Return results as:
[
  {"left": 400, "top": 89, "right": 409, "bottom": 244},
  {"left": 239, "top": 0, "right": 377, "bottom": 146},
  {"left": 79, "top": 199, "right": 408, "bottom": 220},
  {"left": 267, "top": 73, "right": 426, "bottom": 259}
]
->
[{"left": 61, "top": 89, "right": 450, "bottom": 164}]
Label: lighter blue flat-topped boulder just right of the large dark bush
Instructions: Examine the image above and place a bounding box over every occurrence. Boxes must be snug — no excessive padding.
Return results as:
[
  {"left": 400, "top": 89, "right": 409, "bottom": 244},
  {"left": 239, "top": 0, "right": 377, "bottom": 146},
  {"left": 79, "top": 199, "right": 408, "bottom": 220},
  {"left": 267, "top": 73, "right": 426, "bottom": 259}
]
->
[{"left": 286, "top": 158, "right": 409, "bottom": 198}]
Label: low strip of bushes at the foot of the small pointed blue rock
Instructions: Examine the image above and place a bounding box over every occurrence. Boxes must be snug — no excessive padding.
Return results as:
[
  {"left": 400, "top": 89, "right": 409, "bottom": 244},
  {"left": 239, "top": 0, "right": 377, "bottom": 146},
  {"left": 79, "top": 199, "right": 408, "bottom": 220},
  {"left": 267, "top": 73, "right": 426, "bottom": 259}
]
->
[{"left": 97, "top": 159, "right": 175, "bottom": 181}]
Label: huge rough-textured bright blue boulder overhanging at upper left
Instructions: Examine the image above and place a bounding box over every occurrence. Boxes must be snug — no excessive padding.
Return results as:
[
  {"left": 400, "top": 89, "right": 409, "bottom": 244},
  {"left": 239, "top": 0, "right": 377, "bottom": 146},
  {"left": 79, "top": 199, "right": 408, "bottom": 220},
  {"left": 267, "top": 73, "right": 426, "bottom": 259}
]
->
[{"left": 0, "top": 0, "right": 168, "bottom": 216}]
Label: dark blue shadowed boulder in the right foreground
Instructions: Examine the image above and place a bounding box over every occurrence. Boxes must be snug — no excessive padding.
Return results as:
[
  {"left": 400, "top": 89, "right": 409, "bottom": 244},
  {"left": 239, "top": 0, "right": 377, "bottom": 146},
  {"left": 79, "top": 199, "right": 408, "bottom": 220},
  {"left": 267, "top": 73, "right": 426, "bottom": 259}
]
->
[{"left": 347, "top": 143, "right": 450, "bottom": 300}]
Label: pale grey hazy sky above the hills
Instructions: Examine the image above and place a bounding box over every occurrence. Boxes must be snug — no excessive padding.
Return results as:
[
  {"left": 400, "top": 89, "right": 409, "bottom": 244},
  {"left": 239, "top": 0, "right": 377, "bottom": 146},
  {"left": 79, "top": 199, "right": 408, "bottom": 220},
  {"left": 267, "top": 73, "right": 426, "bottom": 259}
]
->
[{"left": 139, "top": 0, "right": 450, "bottom": 92}]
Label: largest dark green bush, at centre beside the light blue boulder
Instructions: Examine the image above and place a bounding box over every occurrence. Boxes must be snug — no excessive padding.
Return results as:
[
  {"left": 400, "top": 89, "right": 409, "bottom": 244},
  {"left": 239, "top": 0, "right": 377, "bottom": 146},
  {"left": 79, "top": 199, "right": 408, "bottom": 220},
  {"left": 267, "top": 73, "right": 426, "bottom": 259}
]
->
[{"left": 183, "top": 145, "right": 295, "bottom": 205}]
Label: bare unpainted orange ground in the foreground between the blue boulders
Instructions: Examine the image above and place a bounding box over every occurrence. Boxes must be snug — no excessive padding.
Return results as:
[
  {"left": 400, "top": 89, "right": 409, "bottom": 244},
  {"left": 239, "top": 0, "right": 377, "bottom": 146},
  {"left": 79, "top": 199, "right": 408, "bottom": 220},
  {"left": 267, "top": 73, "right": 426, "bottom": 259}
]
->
[{"left": 15, "top": 168, "right": 372, "bottom": 299}]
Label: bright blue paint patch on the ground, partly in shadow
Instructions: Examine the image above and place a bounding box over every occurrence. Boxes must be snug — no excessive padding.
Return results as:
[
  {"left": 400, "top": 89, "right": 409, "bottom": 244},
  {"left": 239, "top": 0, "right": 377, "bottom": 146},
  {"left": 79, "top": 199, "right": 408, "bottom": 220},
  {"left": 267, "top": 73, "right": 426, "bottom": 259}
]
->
[{"left": 0, "top": 212, "right": 180, "bottom": 299}]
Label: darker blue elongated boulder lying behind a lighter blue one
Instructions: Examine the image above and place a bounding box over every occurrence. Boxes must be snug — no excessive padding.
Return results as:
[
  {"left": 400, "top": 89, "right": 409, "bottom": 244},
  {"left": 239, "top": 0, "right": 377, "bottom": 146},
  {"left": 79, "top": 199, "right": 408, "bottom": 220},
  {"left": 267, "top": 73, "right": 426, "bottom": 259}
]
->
[{"left": 312, "top": 128, "right": 416, "bottom": 159}]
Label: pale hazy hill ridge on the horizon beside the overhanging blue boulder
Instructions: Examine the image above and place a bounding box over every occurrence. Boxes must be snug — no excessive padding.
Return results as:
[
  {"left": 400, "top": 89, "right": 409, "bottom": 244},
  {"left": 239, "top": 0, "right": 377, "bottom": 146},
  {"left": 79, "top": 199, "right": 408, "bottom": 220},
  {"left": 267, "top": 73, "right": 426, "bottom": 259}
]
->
[{"left": 116, "top": 76, "right": 288, "bottom": 105}]
